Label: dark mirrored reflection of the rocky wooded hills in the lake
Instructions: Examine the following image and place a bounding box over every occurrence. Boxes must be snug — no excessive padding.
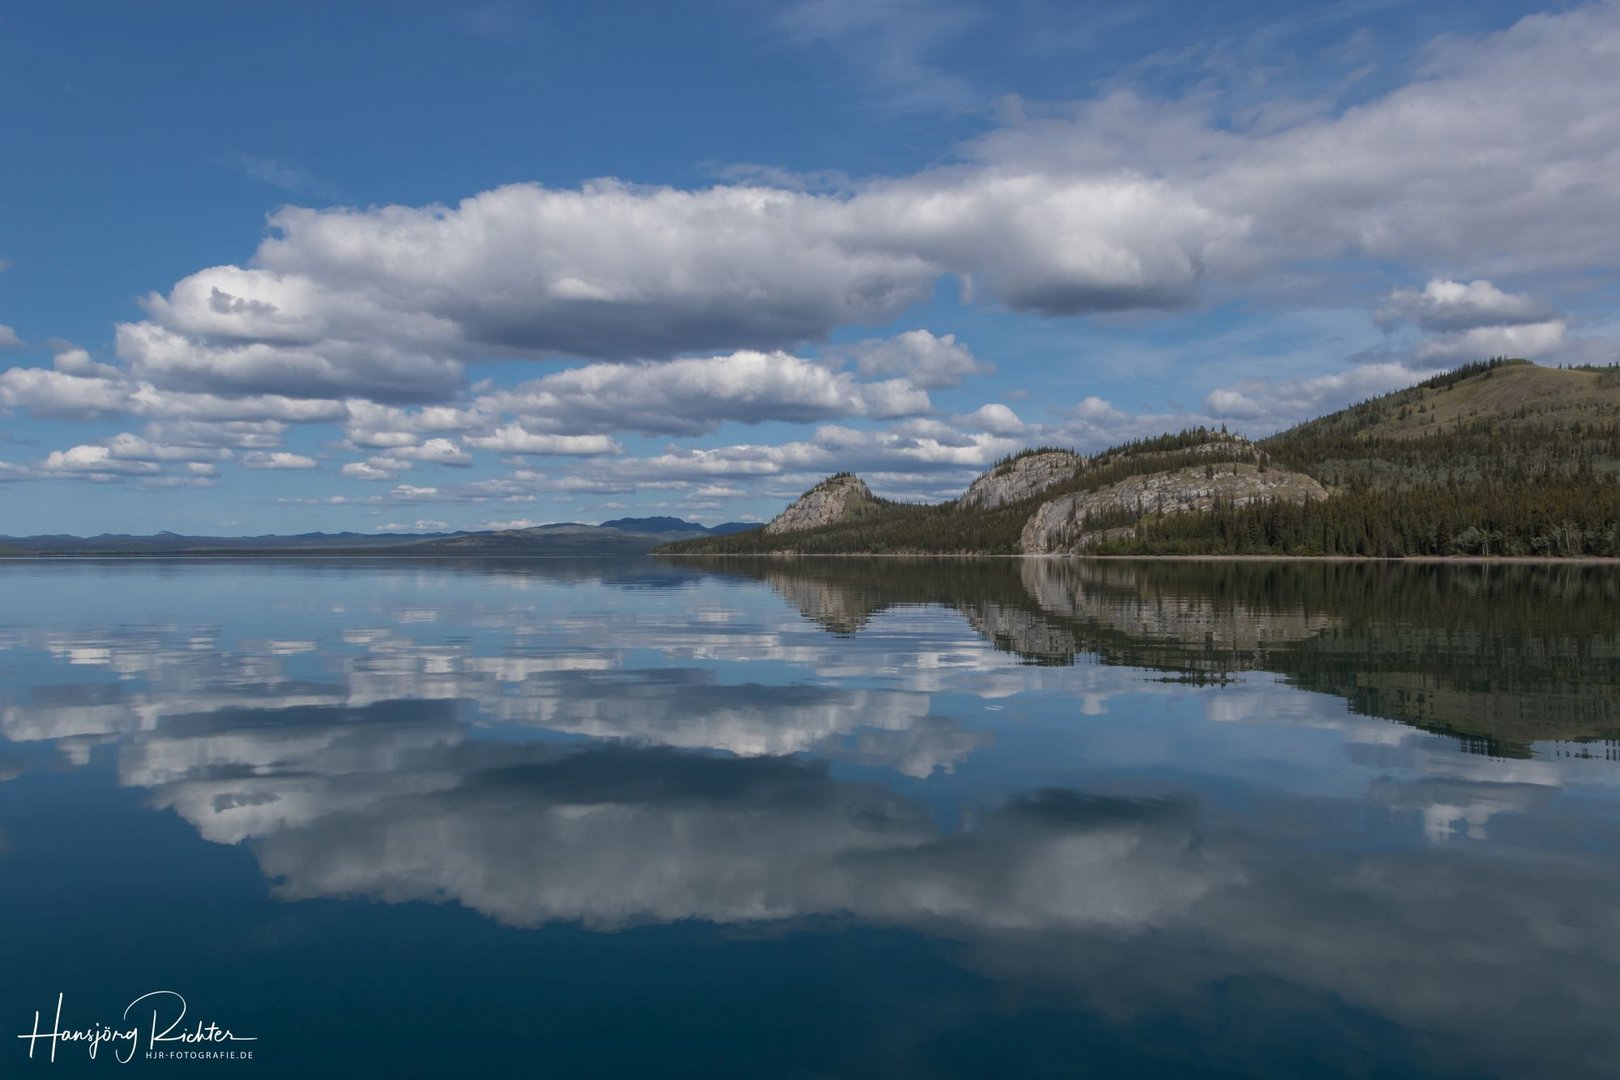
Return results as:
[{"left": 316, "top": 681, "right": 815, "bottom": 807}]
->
[{"left": 682, "top": 559, "right": 1620, "bottom": 756}]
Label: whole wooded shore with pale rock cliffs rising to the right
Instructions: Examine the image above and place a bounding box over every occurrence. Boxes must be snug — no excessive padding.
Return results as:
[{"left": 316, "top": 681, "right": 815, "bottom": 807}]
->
[{"left": 661, "top": 361, "right": 1620, "bottom": 557}]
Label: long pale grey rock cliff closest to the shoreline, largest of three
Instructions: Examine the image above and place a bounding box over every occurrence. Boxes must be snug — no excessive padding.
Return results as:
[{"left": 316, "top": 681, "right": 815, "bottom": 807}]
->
[{"left": 1019, "top": 461, "right": 1327, "bottom": 555}]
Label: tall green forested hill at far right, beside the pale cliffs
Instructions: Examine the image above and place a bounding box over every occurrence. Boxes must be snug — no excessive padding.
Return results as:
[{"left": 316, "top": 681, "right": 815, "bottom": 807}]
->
[{"left": 1095, "top": 359, "right": 1620, "bottom": 557}]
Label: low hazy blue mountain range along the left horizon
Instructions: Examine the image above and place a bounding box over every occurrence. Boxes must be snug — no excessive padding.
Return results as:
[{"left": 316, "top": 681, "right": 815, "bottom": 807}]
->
[{"left": 0, "top": 517, "right": 758, "bottom": 557}]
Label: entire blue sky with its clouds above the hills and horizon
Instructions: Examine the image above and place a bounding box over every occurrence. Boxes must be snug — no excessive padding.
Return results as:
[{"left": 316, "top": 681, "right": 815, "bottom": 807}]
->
[{"left": 0, "top": 0, "right": 1620, "bottom": 534}]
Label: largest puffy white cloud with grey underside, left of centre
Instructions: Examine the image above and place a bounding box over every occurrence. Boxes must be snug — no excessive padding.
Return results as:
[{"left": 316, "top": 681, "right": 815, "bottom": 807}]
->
[{"left": 120, "top": 181, "right": 936, "bottom": 400}]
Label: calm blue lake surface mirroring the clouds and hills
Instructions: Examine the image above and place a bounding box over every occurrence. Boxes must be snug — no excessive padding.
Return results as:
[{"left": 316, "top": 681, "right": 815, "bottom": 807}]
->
[{"left": 0, "top": 559, "right": 1620, "bottom": 1078}]
